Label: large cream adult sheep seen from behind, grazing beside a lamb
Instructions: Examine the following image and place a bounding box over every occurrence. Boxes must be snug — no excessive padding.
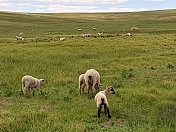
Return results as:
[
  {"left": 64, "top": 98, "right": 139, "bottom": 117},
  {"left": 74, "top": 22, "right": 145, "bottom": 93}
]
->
[{"left": 84, "top": 69, "right": 101, "bottom": 97}]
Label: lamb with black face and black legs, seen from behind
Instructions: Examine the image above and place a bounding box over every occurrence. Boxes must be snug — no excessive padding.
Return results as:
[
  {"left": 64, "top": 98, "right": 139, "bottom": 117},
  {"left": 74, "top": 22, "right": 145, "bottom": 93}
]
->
[{"left": 95, "top": 86, "right": 115, "bottom": 118}]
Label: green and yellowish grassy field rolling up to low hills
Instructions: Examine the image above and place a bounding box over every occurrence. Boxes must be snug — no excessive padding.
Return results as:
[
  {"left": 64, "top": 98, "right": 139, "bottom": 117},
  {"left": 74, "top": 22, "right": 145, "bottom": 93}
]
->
[{"left": 0, "top": 10, "right": 176, "bottom": 132}]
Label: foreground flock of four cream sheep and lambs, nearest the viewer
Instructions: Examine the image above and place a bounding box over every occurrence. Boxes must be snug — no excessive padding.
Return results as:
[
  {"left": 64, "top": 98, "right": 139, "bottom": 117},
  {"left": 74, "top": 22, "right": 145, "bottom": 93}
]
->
[{"left": 22, "top": 69, "right": 115, "bottom": 118}]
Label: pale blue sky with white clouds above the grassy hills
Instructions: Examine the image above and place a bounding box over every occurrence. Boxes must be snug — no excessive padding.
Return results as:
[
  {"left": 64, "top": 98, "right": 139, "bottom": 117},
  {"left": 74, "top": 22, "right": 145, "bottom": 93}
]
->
[{"left": 0, "top": 0, "right": 176, "bottom": 13}]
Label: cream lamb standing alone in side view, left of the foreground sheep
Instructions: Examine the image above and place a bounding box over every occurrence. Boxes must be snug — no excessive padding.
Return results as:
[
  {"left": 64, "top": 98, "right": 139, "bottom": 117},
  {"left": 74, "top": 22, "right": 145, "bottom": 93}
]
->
[{"left": 21, "top": 75, "right": 45, "bottom": 96}]
